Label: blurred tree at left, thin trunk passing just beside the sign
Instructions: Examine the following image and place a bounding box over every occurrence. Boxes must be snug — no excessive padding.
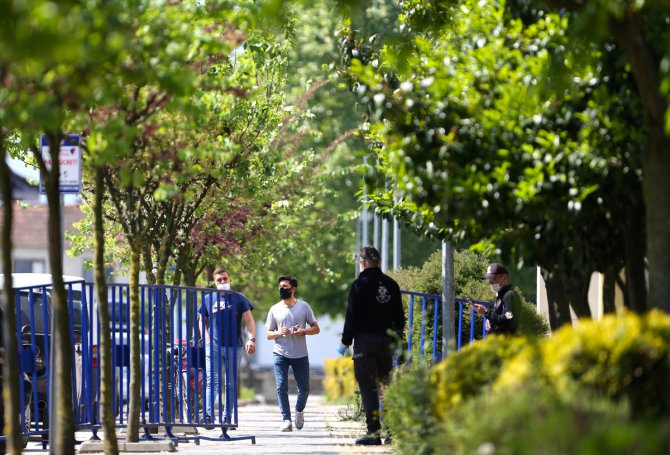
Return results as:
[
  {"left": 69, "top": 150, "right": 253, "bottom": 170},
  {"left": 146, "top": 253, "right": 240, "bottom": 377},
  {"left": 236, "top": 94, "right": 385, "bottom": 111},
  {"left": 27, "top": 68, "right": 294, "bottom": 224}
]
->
[{"left": 0, "top": 0, "right": 136, "bottom": 453}]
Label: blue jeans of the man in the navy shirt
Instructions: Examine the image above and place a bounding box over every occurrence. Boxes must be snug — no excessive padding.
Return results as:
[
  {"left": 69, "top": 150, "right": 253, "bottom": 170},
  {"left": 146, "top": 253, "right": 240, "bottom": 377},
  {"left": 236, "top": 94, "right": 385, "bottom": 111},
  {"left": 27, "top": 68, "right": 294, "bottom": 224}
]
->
[{"left": 203, "top": 344, "right": 244, "bottom": 423}]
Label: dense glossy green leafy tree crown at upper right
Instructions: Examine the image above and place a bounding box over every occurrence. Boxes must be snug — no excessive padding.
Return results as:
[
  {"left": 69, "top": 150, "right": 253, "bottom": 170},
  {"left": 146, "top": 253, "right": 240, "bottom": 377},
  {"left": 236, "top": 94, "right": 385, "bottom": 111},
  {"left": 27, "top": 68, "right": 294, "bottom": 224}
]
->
[{"left": 343, "top": 2, "right": 644, "bottom": 326}]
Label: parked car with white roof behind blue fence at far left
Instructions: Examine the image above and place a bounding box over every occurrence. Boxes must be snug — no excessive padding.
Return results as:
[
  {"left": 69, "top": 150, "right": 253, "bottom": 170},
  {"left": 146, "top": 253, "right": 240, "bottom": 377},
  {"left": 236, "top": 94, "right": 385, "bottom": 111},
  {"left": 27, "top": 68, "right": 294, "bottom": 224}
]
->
[{"left": 0, "top": 273, "right": 84, "bottom": 429}]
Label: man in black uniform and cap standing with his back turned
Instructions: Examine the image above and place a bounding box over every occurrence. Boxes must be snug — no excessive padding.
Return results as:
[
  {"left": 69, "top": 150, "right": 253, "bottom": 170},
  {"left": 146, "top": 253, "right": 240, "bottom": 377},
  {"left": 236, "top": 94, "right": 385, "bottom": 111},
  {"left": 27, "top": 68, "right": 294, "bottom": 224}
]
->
[{"left": 342, "top": 246, "right": 405, "bottom": 445}]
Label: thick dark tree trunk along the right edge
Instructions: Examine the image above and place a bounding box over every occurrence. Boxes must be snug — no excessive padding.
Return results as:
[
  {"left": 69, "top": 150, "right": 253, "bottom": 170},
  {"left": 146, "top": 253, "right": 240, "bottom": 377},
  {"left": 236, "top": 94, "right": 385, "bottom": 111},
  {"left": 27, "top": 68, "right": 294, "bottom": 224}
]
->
[{"left": 547, "top": 0, "right": 670, "bottom": 312}]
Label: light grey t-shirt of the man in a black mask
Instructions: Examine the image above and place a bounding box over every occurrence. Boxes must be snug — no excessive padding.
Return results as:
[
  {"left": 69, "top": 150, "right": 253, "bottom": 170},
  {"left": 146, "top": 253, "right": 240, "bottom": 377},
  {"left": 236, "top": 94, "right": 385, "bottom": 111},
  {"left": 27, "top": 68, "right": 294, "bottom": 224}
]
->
[{"left": 265, "top": 300, "right": 316, "bottom": 359}]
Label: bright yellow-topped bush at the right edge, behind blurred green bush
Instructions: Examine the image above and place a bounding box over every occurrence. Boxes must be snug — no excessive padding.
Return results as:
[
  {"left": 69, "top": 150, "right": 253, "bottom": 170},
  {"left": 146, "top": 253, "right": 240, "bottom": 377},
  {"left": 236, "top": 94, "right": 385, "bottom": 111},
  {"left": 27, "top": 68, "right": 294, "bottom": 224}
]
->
[{"left": 542, "top": 310, "right": 670, "bottom": 418}]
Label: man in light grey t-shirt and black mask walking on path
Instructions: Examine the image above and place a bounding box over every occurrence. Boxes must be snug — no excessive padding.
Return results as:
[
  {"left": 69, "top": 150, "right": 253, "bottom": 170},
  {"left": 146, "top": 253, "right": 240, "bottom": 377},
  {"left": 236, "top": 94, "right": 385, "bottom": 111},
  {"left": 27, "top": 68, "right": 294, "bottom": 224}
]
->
[{"left": 265, "top": 275, "right": 321, "bottom": 431}]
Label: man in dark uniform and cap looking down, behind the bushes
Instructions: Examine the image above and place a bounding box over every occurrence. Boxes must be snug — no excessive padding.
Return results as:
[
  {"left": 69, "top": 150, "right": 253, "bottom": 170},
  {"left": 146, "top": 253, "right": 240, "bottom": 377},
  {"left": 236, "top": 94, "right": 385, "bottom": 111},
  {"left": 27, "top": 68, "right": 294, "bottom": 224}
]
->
[{"left": 473, "top": 263, "right": 519, "bottom": 334}]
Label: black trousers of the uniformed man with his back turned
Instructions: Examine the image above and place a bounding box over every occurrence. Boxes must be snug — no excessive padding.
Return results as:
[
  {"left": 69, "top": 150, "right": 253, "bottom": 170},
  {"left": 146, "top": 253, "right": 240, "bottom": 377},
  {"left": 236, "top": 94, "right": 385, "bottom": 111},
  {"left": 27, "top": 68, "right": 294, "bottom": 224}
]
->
[{"left": 354, "top": 333, "right": 393, "bottom": 433}]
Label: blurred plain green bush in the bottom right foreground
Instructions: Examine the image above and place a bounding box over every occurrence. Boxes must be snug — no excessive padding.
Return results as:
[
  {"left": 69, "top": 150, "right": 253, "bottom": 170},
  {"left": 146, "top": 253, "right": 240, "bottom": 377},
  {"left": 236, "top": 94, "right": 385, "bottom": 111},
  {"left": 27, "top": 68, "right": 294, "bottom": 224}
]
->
[{"left": 432, "top": 383, "right": 668, "bottom": 455}]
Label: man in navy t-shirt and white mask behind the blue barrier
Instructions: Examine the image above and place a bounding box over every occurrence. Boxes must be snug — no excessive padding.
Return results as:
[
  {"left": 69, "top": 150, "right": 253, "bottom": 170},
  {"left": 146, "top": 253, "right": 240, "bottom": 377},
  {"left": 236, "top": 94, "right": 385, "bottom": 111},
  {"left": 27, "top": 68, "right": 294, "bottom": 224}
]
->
[{"left": 198, "top": 268, "right": 256, "bottom": 425}]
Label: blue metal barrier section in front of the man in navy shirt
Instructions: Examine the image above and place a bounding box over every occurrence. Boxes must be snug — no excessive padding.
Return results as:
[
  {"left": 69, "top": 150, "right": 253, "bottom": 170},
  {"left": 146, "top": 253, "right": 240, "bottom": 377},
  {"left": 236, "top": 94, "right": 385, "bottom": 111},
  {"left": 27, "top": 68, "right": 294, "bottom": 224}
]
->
[{"left": 91, "top": 284, "right": 255, "bottom": 443}]
